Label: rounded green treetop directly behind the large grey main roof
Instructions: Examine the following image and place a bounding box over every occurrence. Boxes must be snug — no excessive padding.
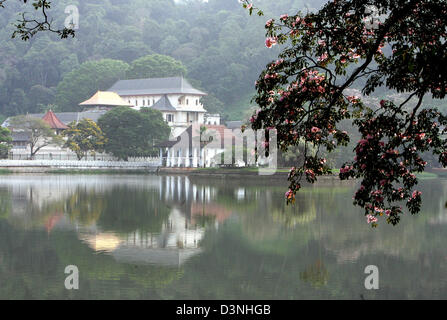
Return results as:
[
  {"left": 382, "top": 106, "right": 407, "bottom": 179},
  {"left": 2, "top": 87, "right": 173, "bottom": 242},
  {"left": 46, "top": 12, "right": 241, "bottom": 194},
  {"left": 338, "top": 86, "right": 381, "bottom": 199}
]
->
[{"left": 127, "top": 54, "right": 186, "bottom": 79}]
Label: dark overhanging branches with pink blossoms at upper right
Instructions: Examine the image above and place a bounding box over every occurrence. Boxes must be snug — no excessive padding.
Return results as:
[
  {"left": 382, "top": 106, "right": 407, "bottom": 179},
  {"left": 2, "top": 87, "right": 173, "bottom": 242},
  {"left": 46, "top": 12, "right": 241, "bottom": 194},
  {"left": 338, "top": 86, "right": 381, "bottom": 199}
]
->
[{"left": 245, "top": 0, "right": 447, "bottom": 226}]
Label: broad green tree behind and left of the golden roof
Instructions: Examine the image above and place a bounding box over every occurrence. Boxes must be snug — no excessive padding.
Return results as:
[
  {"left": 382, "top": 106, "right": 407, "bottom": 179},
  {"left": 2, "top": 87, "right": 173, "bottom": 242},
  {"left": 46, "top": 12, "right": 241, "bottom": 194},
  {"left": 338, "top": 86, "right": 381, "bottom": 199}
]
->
[{"left": 56, "top": 59, "right": 129, "bottom": 111}]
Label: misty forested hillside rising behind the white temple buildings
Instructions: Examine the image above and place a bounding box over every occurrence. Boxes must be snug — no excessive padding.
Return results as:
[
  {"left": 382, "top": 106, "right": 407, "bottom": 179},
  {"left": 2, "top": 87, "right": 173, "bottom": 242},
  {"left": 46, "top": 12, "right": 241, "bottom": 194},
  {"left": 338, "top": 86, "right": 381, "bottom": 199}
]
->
[{"left": 0, "top": 0, "right": 325, "bottom": 122}]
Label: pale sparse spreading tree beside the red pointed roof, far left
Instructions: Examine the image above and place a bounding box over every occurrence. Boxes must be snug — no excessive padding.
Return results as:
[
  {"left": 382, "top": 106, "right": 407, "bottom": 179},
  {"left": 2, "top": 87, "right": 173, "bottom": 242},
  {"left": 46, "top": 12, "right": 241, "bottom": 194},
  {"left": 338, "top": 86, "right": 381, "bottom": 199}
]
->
[{"left": 9, "top": 115, "right": 62, "bottom": 159}]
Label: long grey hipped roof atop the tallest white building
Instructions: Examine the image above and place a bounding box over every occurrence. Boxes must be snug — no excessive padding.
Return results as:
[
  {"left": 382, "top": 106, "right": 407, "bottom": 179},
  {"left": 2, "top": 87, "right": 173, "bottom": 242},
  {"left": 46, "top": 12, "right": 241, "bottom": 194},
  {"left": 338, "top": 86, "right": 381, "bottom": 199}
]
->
[{"left": 109, "top": 77, "right": 206, "bottom": 96}]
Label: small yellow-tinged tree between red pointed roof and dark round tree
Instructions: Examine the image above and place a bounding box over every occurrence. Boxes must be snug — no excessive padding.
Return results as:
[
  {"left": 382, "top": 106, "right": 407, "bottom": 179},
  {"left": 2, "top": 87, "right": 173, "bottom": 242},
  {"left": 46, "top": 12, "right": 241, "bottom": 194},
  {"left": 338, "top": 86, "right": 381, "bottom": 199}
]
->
[{"left": 63, "top": 119, "right": 107, "bottom": 160}]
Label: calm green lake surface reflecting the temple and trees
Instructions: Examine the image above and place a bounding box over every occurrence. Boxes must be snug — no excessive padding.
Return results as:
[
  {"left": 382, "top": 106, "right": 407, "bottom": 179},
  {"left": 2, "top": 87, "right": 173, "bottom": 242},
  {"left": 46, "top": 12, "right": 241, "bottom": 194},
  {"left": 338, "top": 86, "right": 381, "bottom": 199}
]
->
[{"left": 0, "top": 175, "right": 447, "bottom": 299}]
